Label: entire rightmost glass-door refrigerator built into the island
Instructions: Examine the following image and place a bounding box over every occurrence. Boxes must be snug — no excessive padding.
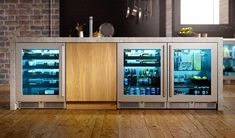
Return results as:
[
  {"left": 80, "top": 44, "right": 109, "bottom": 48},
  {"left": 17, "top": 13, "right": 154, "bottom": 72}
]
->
[{"left": 168, "top": 43, "right": 218, "bottom": 108}]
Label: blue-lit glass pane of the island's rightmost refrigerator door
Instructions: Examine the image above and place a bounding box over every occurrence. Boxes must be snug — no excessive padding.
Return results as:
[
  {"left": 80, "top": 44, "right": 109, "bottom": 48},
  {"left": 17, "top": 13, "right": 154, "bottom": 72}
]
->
[{"left": 174, "top": 49, "right": 211, "bottom": 95}]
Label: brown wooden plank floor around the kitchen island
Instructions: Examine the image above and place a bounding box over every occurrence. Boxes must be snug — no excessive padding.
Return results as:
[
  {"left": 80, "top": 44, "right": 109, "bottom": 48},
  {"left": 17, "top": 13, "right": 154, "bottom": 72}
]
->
[{"left": 0, "top": 85, "right": 235, "bottom": 138}]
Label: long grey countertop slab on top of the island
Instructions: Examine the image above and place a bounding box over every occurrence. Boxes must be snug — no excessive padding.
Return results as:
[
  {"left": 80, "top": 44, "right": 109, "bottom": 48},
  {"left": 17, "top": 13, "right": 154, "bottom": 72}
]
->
[{"left": 15, "top": 37, "right": 223, "bottom": 43}]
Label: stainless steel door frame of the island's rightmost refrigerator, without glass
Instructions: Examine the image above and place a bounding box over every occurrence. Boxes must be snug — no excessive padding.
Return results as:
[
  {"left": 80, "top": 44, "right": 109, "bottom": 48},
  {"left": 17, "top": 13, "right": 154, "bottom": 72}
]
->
[{"left": 168, "top": 43, "right": 218, "bottom": 102}]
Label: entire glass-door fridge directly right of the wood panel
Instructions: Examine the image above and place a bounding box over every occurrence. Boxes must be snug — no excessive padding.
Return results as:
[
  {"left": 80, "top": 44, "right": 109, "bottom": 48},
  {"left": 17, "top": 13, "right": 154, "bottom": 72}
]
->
[{"left": 118, "top": 43, "right": 167, "bottom": 108}]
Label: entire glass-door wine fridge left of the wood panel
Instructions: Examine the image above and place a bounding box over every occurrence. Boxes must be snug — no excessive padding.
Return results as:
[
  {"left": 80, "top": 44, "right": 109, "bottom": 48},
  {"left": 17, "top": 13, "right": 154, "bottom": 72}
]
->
[{"left": 16, "top": 43, "right": 65, "bottom": 108}]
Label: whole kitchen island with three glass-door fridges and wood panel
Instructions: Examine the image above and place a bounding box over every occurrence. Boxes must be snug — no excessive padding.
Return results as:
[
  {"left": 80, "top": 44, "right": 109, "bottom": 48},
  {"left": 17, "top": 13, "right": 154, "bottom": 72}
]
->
[{"left": 10, "top": 37, "right": 223, "bottom": 110}]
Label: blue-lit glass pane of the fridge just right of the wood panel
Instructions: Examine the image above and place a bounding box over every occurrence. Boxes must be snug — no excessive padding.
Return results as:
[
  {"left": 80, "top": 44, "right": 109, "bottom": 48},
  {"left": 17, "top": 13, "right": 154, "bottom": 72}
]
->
[{"left": 123, "top": 49, "right": 161, "bottom": 96}]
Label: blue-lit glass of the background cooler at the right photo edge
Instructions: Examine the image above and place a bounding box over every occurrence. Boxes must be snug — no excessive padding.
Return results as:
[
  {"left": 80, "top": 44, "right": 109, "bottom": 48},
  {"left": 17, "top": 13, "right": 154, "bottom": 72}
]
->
[{"left": 223, "top": 44, "right": 235, "bottom": 76}]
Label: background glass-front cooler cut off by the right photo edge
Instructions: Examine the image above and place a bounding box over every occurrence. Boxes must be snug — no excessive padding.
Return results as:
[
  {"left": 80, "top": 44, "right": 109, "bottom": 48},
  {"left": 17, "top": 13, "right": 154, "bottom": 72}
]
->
[{"left": 223, "top": 39, "right": 235, "bottom": 83}]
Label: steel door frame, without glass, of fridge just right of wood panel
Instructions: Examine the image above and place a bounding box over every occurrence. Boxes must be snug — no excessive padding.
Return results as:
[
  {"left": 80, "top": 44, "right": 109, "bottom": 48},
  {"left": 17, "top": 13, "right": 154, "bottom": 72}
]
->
[{"left": 117, "top": 43, "right": 167, "bottom": 102}]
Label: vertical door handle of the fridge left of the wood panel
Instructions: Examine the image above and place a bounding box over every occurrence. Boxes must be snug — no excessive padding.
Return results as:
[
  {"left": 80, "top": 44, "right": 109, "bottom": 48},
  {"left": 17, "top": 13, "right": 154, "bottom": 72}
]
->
[{"left": 61, "top": 44, "right": 65, "bottom": 97}]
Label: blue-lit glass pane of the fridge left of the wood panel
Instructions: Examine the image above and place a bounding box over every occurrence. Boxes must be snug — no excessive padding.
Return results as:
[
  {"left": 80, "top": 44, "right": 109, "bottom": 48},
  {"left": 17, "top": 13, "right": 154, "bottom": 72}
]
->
[{"left": 22, "top": 49, "right": 59, "bottom": 95}]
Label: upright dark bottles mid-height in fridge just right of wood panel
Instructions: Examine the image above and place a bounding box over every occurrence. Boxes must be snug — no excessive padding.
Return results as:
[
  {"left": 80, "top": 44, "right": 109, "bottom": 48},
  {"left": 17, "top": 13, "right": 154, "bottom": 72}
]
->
[{"left": 124, "top": 69, "right": 160, "bottom": 86}]
